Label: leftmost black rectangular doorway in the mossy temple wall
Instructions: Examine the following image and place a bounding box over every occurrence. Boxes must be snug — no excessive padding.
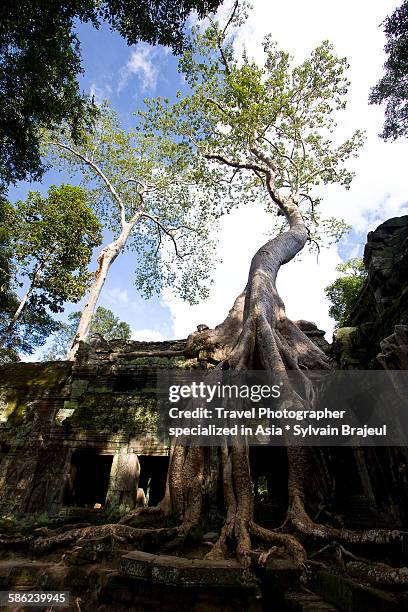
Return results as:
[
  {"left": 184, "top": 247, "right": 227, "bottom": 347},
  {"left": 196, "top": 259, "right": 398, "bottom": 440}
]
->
[{"left": 64, "top": 451, "right": 113, "bottom": 508}]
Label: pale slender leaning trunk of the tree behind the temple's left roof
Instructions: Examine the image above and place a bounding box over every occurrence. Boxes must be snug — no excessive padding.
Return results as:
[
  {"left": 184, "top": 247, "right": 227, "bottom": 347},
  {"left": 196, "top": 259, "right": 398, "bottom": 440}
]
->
[{"left": 67, "top": 223, "right": 135, "bottom": 361}]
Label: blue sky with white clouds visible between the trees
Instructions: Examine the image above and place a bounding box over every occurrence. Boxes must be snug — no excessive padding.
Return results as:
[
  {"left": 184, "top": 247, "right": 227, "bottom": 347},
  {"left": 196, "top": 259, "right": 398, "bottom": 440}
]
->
[{"left": 6, "top": 0, "right": 408, "bottom": 356}]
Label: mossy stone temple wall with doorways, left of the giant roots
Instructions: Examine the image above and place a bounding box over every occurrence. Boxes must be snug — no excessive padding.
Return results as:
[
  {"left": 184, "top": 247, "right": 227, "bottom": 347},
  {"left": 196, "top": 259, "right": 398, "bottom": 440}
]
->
[{"left": 0, "top": 329, "right": 325, "bottom": 516}]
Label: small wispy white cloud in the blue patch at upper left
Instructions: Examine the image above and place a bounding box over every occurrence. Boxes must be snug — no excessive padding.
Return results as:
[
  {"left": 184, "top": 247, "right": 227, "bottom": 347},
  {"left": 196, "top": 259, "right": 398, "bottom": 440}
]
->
[{"left": 118, "top": 43, "right": 159, "bottom": 93}]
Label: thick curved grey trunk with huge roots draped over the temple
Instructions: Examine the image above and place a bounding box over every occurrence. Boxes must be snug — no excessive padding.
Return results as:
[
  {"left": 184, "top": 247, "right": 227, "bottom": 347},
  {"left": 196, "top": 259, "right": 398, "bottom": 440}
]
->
[{"left": 123, "top": 200, "right": 403, "bottom": 568}]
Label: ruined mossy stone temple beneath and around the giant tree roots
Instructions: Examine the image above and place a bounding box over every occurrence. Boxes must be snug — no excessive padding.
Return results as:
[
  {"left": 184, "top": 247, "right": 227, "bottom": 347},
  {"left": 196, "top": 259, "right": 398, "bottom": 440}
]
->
[{"left": 0, "top": 217, "right": 408, "bottom": 612}]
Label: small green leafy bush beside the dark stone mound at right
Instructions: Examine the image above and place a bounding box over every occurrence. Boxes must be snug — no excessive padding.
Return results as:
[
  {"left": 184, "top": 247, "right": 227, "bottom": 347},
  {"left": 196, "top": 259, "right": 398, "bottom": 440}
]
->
[{"left": 325, "top": 258, "right": 367, "bottom": 327}]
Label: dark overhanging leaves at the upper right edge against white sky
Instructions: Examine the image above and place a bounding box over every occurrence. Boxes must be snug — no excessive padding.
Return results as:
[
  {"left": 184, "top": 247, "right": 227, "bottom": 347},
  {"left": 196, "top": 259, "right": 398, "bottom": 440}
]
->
[{"left": 370, "top": 0, "right": 408, "bottom": 140}]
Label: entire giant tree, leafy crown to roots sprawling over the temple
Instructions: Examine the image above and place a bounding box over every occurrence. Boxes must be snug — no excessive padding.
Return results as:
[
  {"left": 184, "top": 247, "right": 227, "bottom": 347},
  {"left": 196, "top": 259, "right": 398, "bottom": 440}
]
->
[{"left": 124, "top": 5, "right": 402, "bottom": 567}]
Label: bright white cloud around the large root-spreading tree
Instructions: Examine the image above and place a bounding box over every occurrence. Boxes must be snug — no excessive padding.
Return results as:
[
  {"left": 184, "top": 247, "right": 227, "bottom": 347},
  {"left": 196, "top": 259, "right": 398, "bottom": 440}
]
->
[{"left": 163, "top": 0, "right": 408, "bottom": 338}]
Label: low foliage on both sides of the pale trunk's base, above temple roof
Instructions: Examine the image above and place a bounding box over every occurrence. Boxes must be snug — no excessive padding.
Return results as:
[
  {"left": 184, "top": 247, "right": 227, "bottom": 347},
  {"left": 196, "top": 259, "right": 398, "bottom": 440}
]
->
[{"left": 43, "top": 306, "right": 131, "bottom": 361}]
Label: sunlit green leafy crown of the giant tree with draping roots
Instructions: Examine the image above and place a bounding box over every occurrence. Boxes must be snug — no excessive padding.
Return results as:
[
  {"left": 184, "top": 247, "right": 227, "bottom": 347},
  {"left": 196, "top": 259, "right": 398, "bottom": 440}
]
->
[{"left": 141, "top": 4, "right": 363, "bottom": 249}]
